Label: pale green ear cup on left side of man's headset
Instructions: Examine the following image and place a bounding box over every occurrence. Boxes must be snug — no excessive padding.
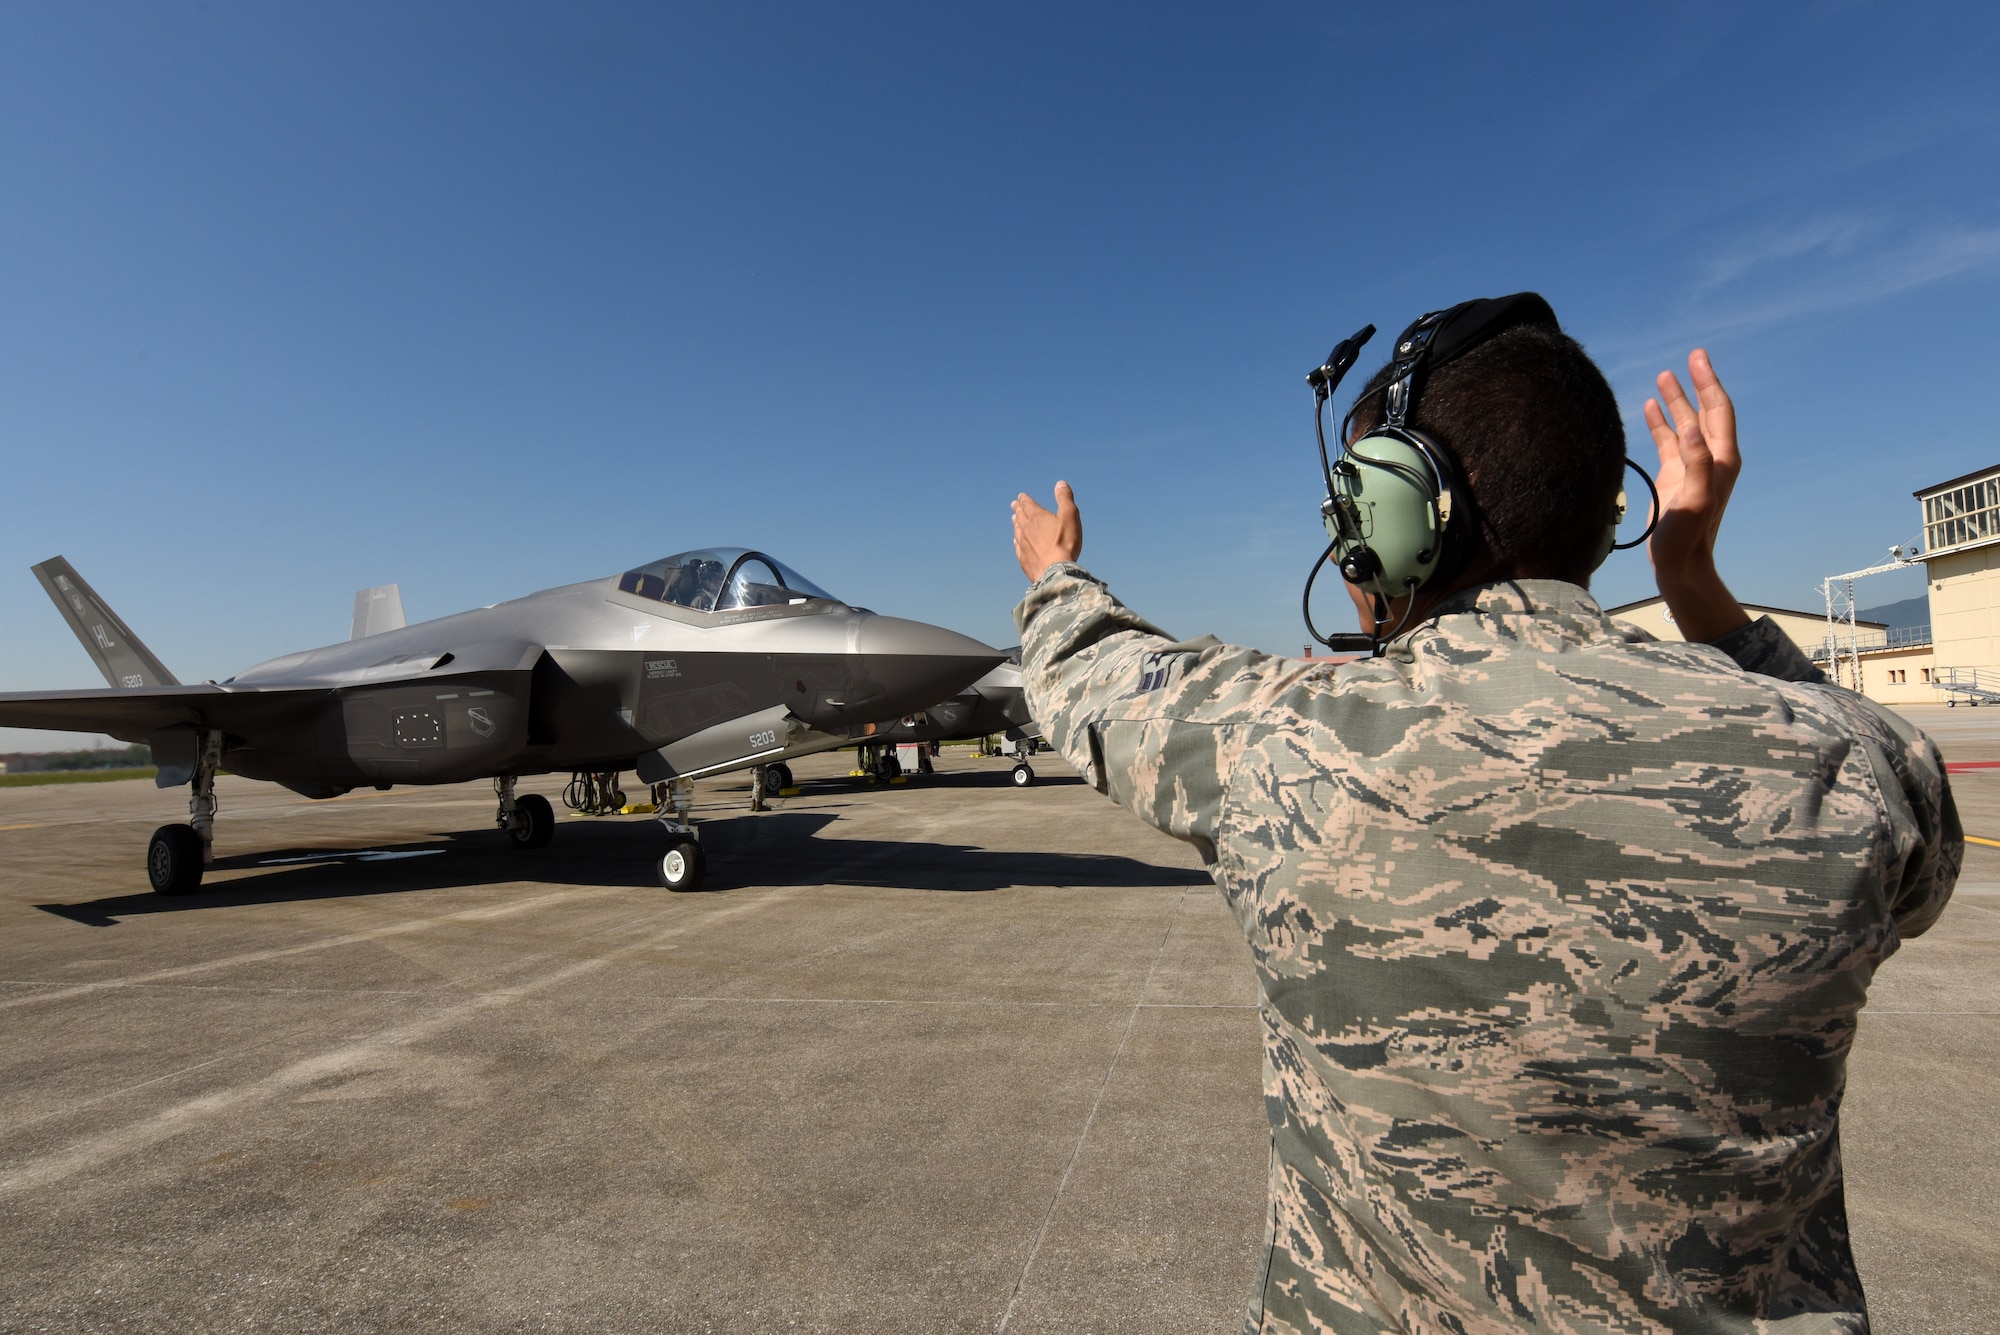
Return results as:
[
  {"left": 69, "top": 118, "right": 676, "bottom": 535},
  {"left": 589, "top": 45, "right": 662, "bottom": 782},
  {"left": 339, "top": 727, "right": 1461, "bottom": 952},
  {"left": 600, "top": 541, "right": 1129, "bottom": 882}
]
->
[{"left": 1324, "top": 436, "right": 1452, "bottom": 598}]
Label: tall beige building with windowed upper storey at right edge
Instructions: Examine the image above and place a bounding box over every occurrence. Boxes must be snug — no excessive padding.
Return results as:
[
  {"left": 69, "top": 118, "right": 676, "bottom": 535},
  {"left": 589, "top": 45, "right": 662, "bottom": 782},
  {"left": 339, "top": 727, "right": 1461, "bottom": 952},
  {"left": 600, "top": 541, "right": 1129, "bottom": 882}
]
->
[{"left": 1916, "top": 466, "right": 2000, "bottom": 691}]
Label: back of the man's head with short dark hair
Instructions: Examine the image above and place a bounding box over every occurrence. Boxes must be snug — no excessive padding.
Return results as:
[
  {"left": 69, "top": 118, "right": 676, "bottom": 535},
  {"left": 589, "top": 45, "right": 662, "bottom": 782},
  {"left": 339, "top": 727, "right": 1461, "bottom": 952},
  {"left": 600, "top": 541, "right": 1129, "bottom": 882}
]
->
[{"left": 1354, "top": 324, "right": 1624, "bottom": 584}]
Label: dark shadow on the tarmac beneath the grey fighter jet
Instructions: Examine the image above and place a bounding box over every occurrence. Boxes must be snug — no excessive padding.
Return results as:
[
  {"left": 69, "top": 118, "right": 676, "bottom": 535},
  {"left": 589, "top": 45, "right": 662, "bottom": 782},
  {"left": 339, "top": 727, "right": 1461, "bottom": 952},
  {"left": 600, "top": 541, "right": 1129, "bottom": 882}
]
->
[{"left": 34, "top": 807, "right": 1210, "bottom": 927}]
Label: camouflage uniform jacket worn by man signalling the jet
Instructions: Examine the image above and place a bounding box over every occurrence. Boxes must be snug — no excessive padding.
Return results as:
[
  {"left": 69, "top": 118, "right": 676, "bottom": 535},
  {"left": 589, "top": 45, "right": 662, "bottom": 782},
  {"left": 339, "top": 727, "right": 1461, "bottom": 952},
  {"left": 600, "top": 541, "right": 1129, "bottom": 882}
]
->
[{"left": 1014, "top": 564, "right": 1964, "bottom": 1335}]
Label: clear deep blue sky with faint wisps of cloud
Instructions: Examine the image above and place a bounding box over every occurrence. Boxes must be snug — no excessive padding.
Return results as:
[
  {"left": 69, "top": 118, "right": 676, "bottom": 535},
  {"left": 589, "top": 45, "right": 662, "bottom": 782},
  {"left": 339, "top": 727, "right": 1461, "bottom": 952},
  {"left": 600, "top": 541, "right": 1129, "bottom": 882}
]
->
[{"left": 0, "top": 4, "right": 2000, "bottom": 749}]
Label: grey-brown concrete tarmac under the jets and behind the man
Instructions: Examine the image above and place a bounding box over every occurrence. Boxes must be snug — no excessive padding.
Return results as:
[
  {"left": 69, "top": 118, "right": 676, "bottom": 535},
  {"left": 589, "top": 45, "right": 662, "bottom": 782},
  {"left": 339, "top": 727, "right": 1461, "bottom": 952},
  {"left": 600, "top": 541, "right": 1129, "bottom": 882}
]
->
[{"left": 0, "top": 709, "right": 2000, "bottom": 1335}]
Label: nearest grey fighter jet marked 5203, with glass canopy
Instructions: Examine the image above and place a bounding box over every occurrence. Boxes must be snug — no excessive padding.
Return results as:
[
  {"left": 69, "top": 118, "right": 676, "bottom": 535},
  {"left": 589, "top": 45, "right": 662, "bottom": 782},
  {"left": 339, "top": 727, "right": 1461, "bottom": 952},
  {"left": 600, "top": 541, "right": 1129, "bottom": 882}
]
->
[{"left": 0, "top": 548, "right": 1002, "bottom": 895}]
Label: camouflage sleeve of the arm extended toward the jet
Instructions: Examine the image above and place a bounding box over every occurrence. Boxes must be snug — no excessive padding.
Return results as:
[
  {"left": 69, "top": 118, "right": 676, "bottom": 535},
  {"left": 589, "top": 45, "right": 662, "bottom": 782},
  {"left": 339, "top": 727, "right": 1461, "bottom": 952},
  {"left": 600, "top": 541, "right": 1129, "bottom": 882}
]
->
[{"left": 1014, "top": 564, "right": 1316, "bottom": 861}]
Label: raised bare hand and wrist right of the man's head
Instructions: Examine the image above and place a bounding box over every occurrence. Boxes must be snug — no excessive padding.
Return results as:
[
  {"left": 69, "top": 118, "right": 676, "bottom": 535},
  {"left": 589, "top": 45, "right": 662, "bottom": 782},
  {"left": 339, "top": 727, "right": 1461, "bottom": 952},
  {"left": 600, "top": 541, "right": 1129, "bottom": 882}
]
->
[{"left": 1646, "top": 348, "right": 1750, "bottom": 642}]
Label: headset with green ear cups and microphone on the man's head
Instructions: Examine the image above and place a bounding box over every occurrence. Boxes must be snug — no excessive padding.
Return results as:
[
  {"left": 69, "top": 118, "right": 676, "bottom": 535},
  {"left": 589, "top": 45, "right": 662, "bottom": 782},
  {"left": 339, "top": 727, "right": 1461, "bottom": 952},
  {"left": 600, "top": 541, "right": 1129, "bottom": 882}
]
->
[{"left": 1304, "top": 292, "right": 1660, "bottom": 656}]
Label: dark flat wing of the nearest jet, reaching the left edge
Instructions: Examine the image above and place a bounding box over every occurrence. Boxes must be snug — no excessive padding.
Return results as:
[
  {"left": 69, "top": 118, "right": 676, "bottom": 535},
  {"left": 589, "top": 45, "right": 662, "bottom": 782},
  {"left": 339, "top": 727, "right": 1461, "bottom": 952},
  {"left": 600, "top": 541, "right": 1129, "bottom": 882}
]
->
[{"left": 0, "top": 685, "right": 334, "bottom": 741}]
